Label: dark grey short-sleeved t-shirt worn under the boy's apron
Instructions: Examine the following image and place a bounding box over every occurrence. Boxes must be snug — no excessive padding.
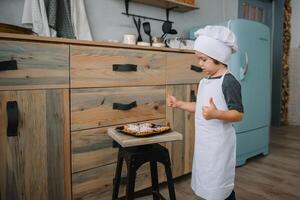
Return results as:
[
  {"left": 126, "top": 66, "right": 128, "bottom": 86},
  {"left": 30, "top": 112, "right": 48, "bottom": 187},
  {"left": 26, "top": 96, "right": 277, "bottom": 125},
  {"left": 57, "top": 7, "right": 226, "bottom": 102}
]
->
[{"left": 209, "top": 73, "right": 244, "bottom": 113}]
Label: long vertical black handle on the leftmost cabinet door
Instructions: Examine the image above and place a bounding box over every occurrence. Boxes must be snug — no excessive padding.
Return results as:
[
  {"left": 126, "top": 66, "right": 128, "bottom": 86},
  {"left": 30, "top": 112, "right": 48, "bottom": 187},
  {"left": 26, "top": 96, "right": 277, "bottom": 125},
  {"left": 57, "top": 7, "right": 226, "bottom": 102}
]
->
[{"left": 6, "top": 101, "right": 19, "bottom": 137}]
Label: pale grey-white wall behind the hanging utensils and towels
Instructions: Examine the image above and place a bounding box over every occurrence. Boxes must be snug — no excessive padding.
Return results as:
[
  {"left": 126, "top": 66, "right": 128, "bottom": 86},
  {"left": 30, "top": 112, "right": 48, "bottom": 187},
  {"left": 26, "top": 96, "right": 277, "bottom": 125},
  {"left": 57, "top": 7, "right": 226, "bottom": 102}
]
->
[{"left": 0, "top": 0, "right": 238, "bottom": 41}]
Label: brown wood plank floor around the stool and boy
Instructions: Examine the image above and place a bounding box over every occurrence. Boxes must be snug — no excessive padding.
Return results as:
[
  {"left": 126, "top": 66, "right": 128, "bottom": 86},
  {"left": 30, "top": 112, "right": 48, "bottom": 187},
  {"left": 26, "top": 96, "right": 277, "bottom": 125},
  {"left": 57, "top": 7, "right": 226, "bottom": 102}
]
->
[{"left": 138, "top": 126, "right": 300, "bottom": 200}]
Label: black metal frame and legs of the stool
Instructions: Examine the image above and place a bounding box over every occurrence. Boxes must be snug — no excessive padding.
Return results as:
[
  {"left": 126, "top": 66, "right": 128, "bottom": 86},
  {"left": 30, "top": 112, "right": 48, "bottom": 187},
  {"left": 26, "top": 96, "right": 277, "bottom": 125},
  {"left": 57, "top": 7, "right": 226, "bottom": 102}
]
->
[{"left": 112, "top": 144, "right": 176, "bottom": 200}]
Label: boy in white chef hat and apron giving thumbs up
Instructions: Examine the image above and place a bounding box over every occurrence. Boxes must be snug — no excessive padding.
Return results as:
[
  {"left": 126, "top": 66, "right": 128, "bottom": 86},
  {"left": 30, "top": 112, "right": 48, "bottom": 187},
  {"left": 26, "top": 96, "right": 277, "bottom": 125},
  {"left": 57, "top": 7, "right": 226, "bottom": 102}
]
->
[{"left": 167, "top": 26, "right": 243, "bottom": 200}]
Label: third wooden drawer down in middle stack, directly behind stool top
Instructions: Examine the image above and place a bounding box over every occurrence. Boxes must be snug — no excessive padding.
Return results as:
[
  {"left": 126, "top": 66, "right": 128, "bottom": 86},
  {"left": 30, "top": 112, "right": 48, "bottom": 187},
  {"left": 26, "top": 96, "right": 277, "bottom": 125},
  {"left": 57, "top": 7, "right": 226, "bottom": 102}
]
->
[{"left": 71, "top": 119, "right": 165, "bottom": 173}]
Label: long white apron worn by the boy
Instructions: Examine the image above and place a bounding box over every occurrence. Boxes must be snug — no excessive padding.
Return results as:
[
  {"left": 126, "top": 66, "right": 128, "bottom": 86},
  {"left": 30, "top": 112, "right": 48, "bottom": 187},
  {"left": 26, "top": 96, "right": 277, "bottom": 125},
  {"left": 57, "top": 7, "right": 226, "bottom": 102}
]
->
[{"left": 192, "top": 72, "right": 236, "bottom": 200}]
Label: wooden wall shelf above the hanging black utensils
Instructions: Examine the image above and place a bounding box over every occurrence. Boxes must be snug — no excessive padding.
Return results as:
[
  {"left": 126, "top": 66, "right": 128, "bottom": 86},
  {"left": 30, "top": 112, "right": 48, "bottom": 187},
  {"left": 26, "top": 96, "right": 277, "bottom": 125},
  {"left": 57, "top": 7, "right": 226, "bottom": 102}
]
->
[{"left": 130, "top": 0, "right": 198, "bottom": 12}]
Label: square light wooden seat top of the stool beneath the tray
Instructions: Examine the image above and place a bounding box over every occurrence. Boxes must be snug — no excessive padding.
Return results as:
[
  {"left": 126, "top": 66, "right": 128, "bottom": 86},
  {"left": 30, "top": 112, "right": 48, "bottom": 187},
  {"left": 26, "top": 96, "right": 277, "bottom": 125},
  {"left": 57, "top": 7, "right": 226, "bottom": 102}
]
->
[{"left": 107, "top": 128, "right": 183, "bottom": 147}]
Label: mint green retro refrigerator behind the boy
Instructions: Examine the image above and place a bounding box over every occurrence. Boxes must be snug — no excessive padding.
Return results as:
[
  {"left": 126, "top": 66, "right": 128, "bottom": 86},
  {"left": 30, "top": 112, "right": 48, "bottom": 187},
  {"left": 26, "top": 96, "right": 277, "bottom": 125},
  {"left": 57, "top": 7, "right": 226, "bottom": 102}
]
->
[{"left": 190, "top": 19, "right": 271, "bottom": 166}]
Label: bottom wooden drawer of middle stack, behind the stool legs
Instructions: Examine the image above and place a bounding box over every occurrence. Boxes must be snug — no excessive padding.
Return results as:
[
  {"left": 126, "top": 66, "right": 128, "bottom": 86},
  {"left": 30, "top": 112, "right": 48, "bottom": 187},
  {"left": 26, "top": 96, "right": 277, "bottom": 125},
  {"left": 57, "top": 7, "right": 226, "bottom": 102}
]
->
[{"left": 72, "top": 159, "right": 166, "bottom": 200}]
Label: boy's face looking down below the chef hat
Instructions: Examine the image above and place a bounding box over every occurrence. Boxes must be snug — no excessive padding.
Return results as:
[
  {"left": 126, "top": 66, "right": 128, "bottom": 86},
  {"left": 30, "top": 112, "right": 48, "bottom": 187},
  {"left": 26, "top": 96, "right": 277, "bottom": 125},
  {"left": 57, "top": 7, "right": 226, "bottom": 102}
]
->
[{"left": 196, "top": 51, "right": 223, "bottom": 76}]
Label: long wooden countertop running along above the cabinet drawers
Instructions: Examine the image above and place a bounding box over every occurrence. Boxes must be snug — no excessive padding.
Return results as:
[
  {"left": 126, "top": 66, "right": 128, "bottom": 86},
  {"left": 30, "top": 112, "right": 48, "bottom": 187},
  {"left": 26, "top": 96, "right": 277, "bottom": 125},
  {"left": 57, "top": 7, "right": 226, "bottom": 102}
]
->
[{"left": 0, "top": 33, "right": 194, "bottom": 53}]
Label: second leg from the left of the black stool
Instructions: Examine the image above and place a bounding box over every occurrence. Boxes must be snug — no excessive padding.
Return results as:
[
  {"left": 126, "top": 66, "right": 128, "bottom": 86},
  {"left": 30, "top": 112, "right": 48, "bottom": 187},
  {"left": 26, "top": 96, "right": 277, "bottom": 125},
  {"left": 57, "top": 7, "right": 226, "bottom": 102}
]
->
[{"left": 126, "top": 160, "right": 136, "bottom": 200}]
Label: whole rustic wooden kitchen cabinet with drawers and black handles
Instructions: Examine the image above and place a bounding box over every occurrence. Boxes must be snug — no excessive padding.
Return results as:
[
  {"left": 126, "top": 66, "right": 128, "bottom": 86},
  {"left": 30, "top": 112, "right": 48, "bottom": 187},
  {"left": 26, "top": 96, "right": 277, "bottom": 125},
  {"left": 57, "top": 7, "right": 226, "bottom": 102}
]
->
[{"left": 0, "top": 32, "right": 203, "bottom": 200}]
